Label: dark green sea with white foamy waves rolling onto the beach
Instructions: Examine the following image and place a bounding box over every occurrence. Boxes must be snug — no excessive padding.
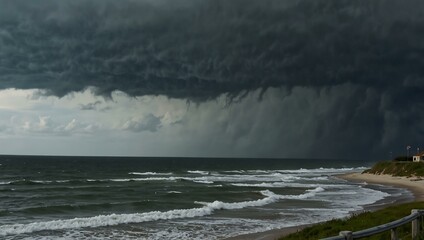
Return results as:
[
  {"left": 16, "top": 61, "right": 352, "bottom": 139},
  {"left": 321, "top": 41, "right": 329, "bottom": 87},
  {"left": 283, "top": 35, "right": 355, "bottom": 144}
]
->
[{"left": 0, "top": 156, "right": 410, "bottom": 239}]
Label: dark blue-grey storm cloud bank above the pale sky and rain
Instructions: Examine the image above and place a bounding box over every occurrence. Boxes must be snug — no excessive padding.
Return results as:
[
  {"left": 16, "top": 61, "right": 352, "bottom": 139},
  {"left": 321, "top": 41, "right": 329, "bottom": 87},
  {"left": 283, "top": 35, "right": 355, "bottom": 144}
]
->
[{"left": 0, "top": 0, "right": 424, "bottom": 100}]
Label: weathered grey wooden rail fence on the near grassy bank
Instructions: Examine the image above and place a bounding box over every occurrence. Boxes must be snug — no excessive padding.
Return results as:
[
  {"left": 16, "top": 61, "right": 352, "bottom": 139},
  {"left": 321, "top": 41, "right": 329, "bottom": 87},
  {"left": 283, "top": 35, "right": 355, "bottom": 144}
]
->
[{"left": 321, "top": 209, "right": 424, "bottom": 240}]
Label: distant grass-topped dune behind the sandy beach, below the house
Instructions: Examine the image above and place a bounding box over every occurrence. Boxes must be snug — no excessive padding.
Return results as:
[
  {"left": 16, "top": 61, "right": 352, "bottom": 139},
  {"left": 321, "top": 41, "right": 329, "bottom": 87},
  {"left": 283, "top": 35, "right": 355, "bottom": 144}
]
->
[{"left": 365, "top": 161, "right": 424, "bottom": 177}]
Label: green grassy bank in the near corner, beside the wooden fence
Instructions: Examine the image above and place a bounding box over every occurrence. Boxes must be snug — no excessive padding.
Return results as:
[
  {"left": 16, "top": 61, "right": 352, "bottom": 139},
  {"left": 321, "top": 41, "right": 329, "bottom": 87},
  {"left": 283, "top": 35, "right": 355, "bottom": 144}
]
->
[{"left": 280, "top": 202, "right": 424, "bottom": 240}]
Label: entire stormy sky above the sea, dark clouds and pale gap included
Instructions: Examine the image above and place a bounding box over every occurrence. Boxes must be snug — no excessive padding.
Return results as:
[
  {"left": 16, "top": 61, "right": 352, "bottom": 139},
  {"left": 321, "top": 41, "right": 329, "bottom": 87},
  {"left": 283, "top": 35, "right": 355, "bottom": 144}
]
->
[{"left": 0, "top": 0, "right": 424, "bottom": 159}]
